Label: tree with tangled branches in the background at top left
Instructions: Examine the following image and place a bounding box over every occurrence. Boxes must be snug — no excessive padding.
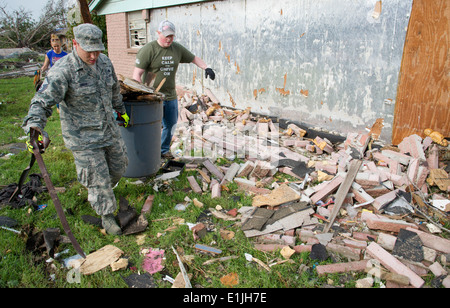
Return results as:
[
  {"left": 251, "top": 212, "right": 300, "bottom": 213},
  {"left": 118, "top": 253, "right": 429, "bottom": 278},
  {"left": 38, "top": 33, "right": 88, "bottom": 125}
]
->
[{"left": 0, "top": 0, "right": 67, "bottom": 48}]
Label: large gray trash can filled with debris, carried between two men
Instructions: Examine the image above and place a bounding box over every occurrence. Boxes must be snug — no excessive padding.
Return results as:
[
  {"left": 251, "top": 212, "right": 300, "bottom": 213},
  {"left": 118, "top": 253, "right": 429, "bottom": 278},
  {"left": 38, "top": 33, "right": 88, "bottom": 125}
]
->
[{"left": 120, "top": 100, "right": 163, "bottom": 178}]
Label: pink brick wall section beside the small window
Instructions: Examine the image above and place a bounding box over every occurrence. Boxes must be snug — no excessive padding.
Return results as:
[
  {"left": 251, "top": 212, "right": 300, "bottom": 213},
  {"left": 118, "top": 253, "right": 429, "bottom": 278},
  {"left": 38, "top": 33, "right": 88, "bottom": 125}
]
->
[{"left": 106, "top": 13, "right": 137, "bottom": 78}]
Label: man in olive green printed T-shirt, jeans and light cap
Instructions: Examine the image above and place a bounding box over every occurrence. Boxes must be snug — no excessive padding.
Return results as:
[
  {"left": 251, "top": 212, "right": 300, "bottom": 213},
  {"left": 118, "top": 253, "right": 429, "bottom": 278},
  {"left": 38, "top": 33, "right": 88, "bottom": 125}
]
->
[{"left": 133, "top": 20, "right": 215, "bottom": 159}]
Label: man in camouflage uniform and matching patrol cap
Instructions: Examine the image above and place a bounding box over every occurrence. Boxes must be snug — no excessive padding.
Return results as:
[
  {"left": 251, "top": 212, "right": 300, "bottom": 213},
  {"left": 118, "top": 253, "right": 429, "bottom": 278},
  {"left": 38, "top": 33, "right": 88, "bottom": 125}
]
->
[{"left": 23, "top": 24, "right": 129, "bottom": 235}]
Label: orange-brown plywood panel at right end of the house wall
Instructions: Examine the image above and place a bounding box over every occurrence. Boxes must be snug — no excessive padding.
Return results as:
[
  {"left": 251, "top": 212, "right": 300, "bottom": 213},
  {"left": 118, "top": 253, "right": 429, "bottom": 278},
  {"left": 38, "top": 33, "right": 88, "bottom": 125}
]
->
[{"left": 392, "top": 0, "right": 450, "bottom": 144}]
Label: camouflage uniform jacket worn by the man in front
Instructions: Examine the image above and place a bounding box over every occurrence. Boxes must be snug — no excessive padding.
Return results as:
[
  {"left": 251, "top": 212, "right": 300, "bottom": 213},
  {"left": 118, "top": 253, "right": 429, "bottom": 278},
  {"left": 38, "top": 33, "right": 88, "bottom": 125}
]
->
[{"left": 22, "top": 50, "right": 126, "bottom": 151}]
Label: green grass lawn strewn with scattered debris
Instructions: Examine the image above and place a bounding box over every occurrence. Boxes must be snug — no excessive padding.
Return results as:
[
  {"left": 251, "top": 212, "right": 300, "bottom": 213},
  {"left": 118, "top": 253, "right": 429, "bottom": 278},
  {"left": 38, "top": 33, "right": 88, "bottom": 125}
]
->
[{"left": 0, "top": 77, "right": 440, "bottom": 288}]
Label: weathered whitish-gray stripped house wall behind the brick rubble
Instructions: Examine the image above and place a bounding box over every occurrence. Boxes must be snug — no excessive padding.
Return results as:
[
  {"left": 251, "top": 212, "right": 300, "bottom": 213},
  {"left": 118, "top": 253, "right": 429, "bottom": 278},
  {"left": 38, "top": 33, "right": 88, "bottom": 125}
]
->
[{"left": 149, "top": 0, "right": 412, "bottom": 141}]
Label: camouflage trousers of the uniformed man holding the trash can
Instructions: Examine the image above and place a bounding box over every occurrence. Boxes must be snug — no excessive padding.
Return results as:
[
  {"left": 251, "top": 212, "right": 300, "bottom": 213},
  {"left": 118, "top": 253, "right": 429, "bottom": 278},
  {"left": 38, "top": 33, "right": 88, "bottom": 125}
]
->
[{"left": 73, "top": 140, "right": 128, "bottom": 215}]
